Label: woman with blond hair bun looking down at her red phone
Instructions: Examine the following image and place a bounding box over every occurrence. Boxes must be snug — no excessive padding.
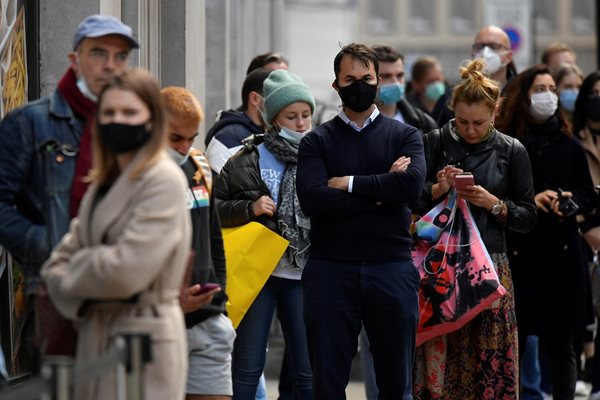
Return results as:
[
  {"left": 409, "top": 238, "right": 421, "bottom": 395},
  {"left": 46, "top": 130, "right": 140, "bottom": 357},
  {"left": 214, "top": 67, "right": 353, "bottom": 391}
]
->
[{"left": 414, "top": 59, "right": 536, "bottom": 400}]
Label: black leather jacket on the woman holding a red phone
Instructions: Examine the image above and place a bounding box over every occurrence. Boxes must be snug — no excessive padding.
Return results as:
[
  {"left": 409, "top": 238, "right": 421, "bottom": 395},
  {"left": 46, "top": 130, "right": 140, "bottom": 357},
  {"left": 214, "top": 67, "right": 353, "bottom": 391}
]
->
[{"left": 413, "top": 120, "right": 536, "bottom": 253}]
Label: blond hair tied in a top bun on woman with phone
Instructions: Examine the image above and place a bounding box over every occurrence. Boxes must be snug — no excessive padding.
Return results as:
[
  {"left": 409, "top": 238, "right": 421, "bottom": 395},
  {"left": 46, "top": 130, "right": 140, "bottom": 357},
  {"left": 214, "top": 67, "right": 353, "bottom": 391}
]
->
[{"left": 449, "top": 59, "right": 500, "bottom": 110}]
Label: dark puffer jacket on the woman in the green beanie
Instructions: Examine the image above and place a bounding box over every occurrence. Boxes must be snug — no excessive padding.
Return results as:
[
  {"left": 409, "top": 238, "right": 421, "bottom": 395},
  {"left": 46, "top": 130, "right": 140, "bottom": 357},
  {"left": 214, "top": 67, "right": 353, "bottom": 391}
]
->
[{"left": 214, "top": 134, "right": 276, "bottom": 230}]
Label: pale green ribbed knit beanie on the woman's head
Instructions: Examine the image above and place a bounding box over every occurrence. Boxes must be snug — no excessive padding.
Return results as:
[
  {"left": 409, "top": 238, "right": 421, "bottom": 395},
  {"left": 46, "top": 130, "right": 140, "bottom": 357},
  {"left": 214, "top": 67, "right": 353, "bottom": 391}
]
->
[{"left": 263, "top": 69, "right": 315, "bottom": 125}]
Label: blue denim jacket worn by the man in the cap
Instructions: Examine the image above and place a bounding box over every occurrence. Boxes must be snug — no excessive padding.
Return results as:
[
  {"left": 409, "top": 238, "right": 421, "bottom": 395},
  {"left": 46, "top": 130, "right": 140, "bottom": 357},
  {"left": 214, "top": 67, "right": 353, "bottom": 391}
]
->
[{"left": 0, "top": 91, "right": 84, "bottom": 294}]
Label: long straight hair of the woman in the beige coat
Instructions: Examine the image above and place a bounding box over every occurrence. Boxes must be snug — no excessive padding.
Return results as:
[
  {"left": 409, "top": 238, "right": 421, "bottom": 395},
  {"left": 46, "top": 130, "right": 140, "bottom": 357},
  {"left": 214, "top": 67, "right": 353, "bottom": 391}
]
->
[{"left": 89, "top": 68, "right": 166, "bottom": 185}]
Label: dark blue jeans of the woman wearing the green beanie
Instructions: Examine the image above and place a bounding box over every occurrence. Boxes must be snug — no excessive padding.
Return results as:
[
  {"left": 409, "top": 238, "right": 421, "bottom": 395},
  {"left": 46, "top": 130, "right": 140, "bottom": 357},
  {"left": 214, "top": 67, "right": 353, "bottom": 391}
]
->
[{"left": 232, "top": 276, "right": 312, "bottom": 400}]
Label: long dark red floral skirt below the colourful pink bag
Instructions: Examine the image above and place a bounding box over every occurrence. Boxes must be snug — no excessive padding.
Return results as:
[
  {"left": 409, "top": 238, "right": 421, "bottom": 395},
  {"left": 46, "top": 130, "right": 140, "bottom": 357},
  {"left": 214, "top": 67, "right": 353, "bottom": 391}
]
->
[{"left": 413, "top": 254, "right": 519, "bottom": 400}]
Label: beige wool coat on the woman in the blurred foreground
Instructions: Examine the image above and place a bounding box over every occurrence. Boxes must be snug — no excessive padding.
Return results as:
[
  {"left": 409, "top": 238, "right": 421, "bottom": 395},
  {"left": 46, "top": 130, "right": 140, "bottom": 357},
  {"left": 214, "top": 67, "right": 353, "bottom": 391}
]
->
[{"left": 42, "top": 155, "right": 191, "bottom": 400}]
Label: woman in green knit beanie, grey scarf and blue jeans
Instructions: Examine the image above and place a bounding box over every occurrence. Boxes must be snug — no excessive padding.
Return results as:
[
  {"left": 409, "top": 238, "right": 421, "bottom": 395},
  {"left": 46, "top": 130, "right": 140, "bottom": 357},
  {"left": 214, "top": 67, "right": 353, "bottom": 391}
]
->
[{"left": 215, "top": 70, "right": 315, "bottom": 400}]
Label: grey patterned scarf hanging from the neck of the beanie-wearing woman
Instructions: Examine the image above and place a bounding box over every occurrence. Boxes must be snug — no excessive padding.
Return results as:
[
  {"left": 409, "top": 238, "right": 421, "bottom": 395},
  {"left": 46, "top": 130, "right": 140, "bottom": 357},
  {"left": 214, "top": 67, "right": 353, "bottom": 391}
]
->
[{"left": 264, "top": 129, "right": 310, "bottom": 268}]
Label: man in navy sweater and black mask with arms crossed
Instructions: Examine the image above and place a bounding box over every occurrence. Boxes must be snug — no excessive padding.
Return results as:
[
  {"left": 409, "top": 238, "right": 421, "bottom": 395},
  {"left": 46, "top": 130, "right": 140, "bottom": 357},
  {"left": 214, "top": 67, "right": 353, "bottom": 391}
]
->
[{"left": 297, "top": 43, "right": 426, "bottom": 400}]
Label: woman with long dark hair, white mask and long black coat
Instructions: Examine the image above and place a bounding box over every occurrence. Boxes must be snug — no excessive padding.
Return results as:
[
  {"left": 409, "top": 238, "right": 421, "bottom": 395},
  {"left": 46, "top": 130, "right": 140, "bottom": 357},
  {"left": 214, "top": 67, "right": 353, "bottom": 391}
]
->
[{"left": 497, "top": 64, "right": 596, "bottom": 400}]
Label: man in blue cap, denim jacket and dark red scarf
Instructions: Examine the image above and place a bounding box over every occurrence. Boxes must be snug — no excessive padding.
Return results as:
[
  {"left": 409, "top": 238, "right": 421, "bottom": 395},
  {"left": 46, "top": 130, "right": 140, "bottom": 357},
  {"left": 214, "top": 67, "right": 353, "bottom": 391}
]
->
[{"left": 0, "top": 15, "right": 139, "bottom": 367}]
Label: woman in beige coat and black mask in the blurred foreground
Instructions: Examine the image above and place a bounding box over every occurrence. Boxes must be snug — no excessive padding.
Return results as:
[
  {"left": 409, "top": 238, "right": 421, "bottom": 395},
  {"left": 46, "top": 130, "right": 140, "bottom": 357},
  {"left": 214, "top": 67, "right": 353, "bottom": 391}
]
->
[{"left": 42, "top": 69, "right": 191, "bottom": 400}]
